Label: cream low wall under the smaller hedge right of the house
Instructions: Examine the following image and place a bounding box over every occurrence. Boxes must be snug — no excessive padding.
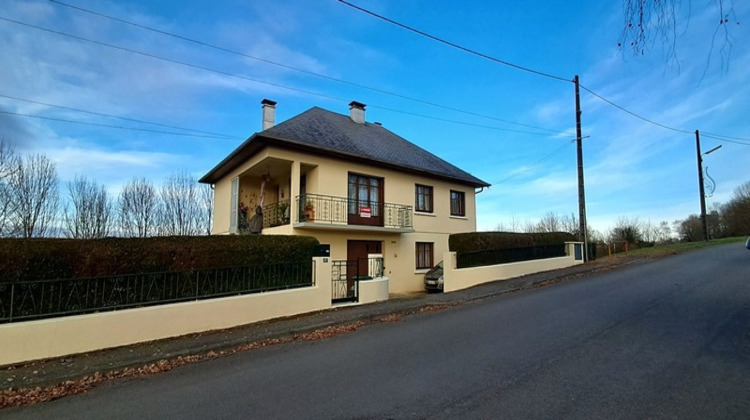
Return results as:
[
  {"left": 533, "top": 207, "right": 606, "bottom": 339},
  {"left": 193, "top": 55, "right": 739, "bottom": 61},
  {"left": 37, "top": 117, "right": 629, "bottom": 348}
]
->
[{"left": 443, "top": 242, "right": 583, "bottom": 292}]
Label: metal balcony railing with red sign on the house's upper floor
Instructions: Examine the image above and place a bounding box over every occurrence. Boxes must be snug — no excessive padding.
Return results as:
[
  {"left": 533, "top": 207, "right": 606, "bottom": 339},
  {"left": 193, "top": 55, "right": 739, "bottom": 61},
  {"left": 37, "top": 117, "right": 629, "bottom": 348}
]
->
[{"left": 297, "top": 194, "right": 413, "bottom": 229}]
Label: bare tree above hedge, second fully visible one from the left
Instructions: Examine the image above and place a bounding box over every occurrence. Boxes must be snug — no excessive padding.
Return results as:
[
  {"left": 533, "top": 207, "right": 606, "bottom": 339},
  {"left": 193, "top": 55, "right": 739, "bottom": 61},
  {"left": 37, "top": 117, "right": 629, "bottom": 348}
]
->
[{"left": 64, "top": 176, "right": 112, "bottom": 239}]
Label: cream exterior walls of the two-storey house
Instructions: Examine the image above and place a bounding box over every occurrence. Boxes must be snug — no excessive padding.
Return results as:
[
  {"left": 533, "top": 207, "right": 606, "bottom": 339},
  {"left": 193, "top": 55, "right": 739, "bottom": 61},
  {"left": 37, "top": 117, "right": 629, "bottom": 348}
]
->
[{"left": 214, "top": 147, "right": 476, "bottom": 293}]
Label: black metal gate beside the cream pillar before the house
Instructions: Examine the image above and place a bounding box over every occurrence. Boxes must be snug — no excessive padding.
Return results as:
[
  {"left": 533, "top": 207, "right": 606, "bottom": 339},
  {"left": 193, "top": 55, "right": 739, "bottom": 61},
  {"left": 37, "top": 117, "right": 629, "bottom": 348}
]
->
[{"left": 331, "top": 256, "right": 384, "bottom": 303}]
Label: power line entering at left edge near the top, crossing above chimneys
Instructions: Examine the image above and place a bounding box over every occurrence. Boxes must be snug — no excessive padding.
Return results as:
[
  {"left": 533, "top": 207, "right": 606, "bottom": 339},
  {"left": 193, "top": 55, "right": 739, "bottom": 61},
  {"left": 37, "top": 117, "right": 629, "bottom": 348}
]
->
[{"left": 0, "top": 16, "right": 563, "bottom": 138}]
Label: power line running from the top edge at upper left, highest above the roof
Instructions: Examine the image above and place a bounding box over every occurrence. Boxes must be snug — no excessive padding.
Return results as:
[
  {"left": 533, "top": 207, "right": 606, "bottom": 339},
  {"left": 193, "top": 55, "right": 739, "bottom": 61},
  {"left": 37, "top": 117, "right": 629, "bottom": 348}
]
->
[{"left": 49, "top": 0, "right": 560, "bottom": 133}]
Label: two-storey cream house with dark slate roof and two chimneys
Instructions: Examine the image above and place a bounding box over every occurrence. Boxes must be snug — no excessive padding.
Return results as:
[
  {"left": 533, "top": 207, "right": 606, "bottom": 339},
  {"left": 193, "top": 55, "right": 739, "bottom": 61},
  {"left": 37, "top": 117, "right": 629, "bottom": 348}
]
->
[{"left": 200, "top": 99, "right": 489, "bottom": 293}]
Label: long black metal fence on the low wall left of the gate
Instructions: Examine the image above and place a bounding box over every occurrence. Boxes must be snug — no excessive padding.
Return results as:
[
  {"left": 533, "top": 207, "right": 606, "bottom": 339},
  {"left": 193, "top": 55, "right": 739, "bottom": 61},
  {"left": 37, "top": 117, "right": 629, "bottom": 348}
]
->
[{"left": 0, "top": 261, "right": 313, "bottom": 323}]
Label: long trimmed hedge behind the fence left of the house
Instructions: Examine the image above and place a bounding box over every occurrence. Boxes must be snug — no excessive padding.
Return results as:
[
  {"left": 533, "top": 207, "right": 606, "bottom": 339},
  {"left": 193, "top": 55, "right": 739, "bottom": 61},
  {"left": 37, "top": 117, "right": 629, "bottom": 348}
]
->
[{"left": 0, "top": 235, "right": 318, "bottom": 281}]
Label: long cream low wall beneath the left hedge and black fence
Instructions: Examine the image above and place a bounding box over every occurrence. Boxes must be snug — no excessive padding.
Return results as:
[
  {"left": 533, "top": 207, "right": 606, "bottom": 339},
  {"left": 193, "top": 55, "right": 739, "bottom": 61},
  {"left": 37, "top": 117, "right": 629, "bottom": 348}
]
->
[{"left": 0, "top": 258, "right": 332, "bottom": 366}]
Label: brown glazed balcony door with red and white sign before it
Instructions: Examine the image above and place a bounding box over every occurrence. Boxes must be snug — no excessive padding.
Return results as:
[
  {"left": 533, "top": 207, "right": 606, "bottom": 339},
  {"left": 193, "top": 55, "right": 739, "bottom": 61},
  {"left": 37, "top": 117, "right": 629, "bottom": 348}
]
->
[{"left": 348, "top": 173, "right": 384, "bottom": 226}]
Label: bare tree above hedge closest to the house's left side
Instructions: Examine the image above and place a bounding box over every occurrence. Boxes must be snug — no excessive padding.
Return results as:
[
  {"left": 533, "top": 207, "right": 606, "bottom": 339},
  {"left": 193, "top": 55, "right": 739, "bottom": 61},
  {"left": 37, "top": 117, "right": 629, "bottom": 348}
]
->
[{"left": 159, "top": 173, "right": 203, "bottom": 236}]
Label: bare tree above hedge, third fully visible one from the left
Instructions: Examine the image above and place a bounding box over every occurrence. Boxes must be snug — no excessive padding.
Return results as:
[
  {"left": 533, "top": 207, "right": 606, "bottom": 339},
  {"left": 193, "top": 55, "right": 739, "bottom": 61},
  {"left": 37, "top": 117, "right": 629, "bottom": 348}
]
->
[{"left": 118, "top": 178, "right": 159, "bottom": 238}]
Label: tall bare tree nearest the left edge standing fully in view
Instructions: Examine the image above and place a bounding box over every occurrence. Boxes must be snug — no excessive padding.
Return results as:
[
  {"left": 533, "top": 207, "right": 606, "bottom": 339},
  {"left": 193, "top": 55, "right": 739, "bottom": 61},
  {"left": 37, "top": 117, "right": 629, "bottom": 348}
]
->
[{"left": 9, "top": 154, "right": 59, "bottom": 238}]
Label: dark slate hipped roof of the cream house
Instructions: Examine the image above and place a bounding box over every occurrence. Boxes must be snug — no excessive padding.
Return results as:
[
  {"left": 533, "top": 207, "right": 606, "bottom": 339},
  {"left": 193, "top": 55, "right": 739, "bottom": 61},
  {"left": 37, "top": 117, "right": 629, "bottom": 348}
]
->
[{"left": 200, "top": 107, "right": 490, "bottom": 187}]
